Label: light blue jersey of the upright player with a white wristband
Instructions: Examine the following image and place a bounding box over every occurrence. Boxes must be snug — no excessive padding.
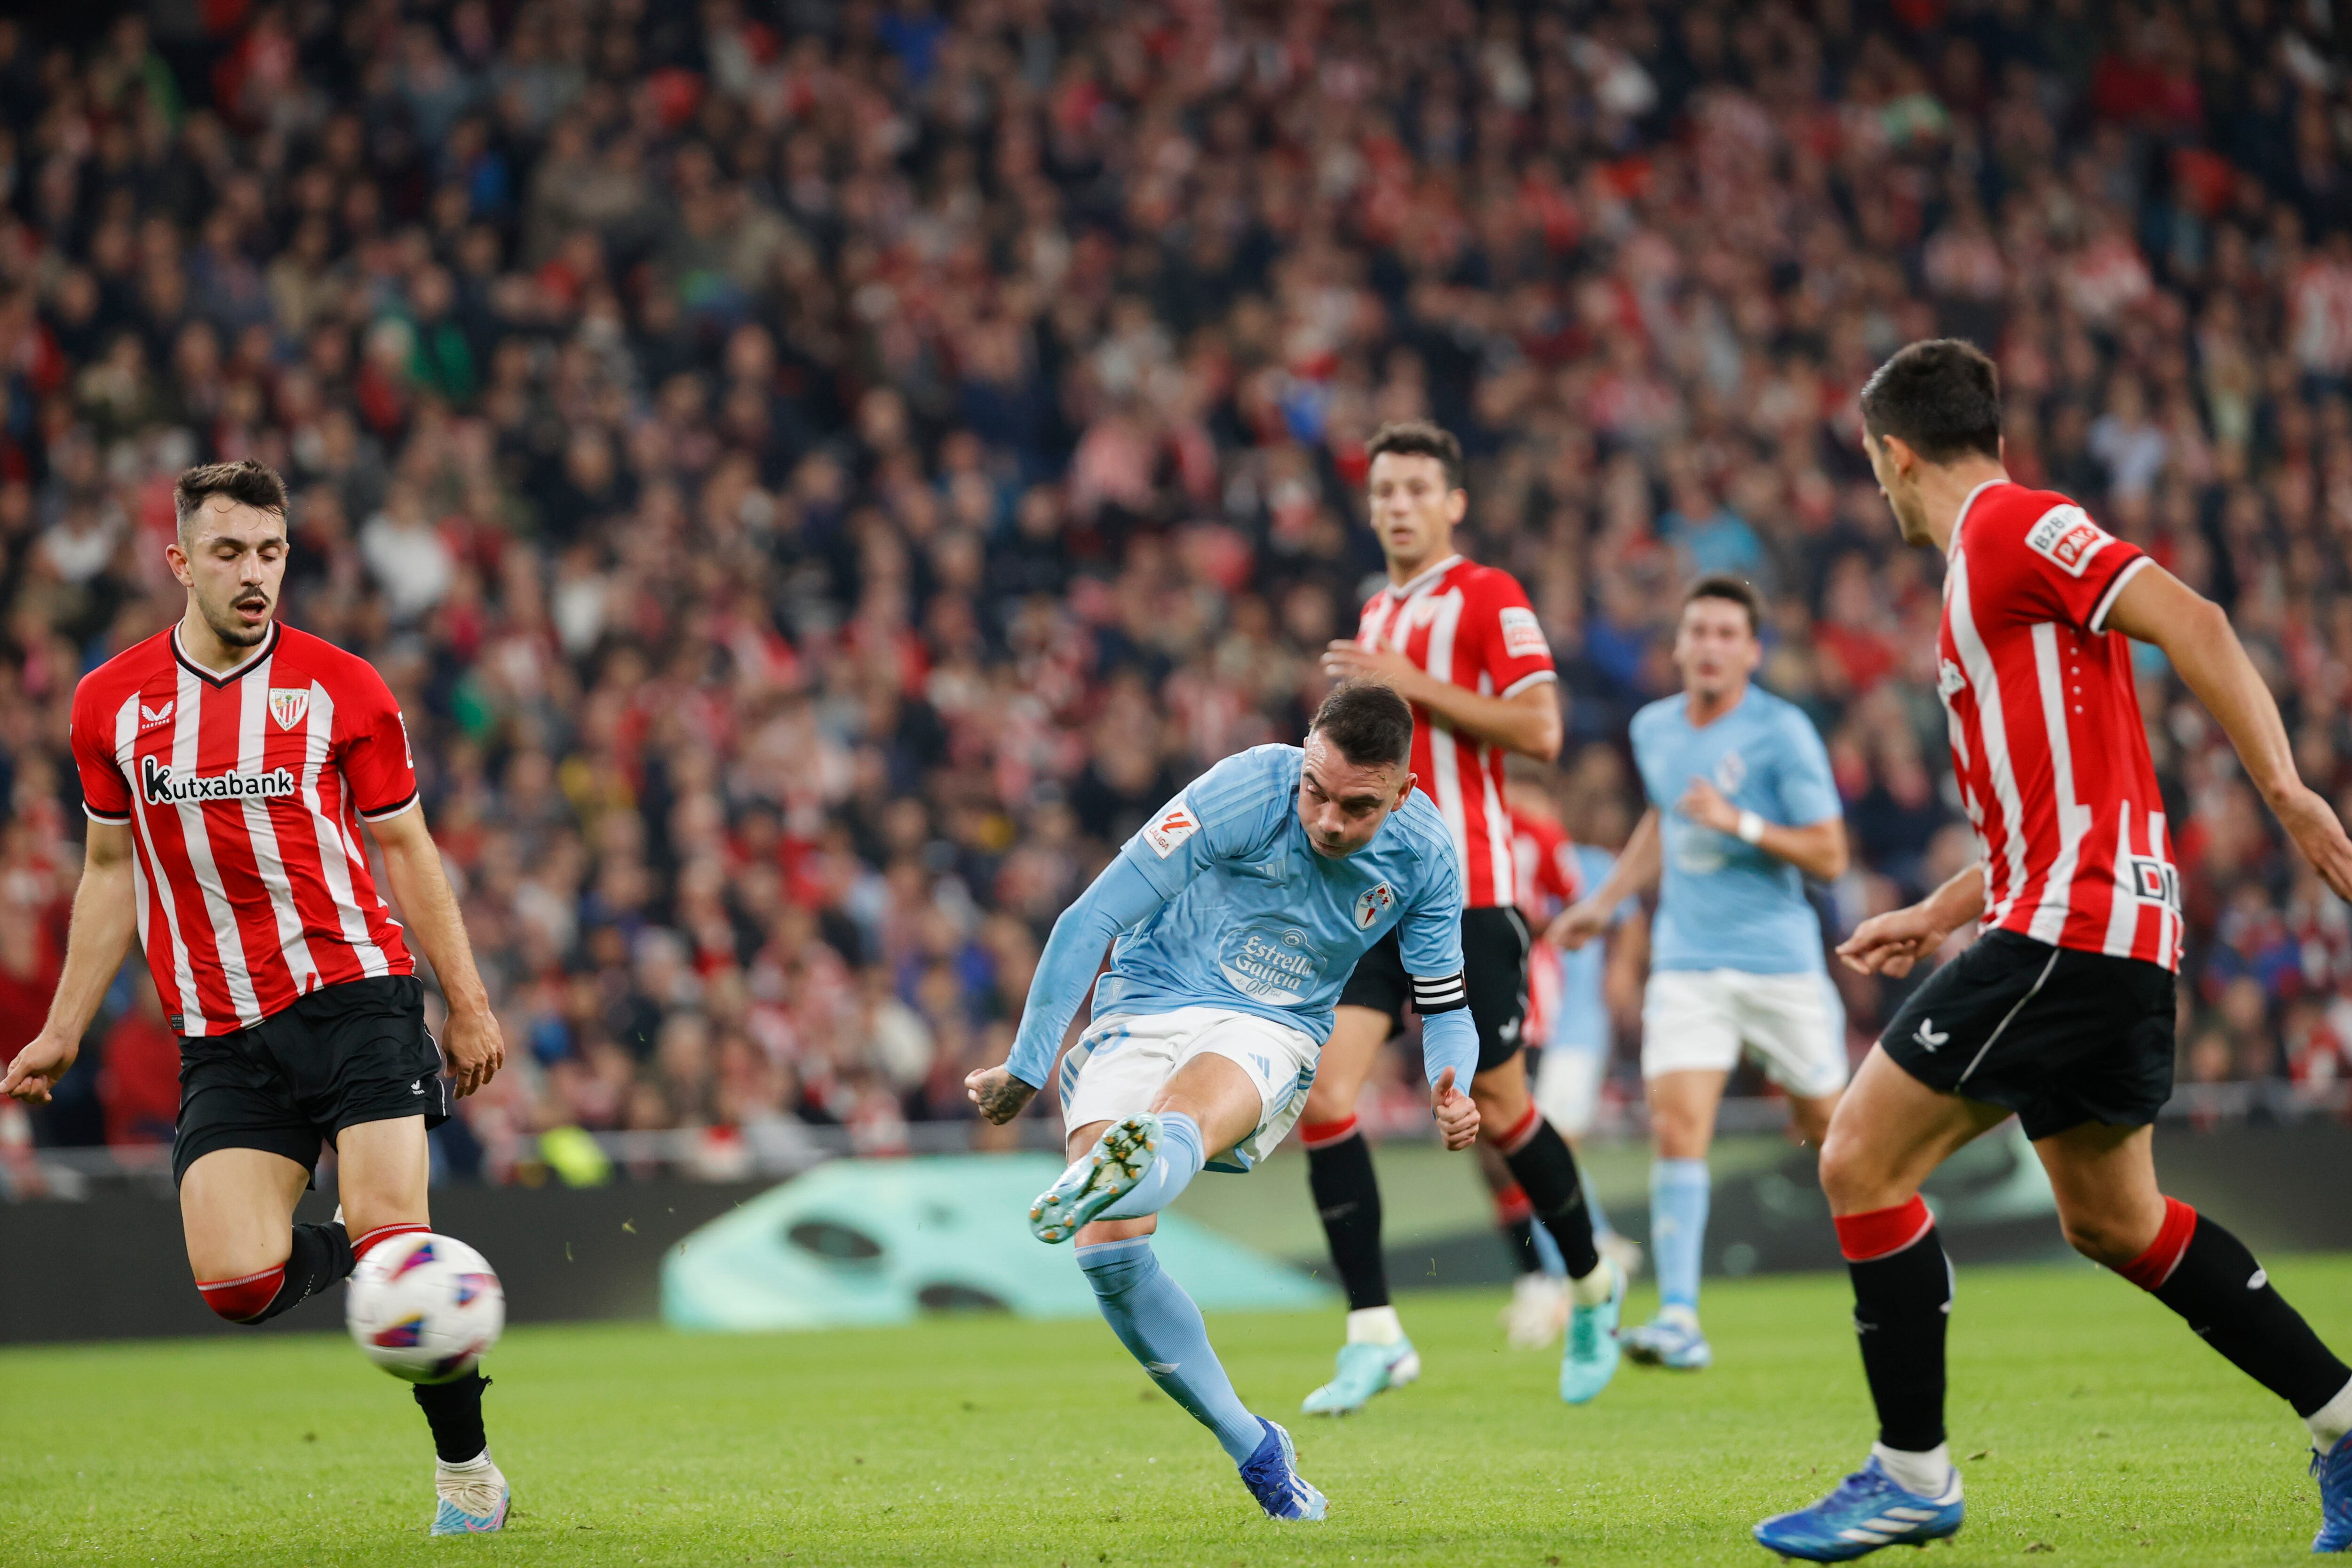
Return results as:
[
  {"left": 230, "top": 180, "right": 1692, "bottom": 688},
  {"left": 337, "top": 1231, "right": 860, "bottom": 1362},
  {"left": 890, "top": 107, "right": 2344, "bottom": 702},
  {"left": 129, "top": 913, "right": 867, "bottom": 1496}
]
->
[{"left": 1632, "top": 686, "right": 1839, "bottom": 976}]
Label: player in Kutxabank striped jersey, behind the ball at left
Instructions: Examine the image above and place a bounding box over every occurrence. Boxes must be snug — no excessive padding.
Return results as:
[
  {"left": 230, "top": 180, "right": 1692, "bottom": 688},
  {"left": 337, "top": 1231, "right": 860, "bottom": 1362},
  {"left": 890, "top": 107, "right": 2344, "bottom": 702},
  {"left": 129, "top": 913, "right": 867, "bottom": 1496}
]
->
[{"left": 0, "top": 461, "right": 508, "bottom": 1535}]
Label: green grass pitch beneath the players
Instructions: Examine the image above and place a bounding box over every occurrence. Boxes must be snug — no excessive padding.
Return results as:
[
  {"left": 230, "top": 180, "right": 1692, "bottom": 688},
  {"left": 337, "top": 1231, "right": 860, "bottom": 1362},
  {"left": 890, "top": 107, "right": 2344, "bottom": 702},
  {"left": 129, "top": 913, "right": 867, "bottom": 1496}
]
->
[{"left": 0, "top": 1258, "right": 2352, "bottom": 1568}]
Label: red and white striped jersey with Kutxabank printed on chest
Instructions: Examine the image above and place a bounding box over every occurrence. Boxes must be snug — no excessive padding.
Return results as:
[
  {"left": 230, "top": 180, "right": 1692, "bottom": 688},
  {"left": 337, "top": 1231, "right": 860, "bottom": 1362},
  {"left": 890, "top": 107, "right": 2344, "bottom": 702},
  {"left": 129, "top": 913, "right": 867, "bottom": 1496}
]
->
[{"left": 73, "top": 625, "right": 416, "bottom": 1035}]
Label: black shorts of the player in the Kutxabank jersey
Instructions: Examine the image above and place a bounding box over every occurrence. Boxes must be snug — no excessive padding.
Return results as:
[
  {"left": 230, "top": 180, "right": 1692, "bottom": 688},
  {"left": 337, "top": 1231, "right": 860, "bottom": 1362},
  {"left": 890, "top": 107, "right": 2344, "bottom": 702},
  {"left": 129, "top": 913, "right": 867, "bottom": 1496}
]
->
[{"left": 172, "top": 976, "right": 449, "bottom": 1182}]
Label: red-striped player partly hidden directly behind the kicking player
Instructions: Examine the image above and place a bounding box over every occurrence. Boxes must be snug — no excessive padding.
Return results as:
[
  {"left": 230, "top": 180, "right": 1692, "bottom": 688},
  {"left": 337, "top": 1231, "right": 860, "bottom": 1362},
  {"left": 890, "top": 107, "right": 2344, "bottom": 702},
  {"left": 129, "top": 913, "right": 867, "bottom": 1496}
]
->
[{"left": 1298, "top": 423, "right": 1625, "bottom": 1415}]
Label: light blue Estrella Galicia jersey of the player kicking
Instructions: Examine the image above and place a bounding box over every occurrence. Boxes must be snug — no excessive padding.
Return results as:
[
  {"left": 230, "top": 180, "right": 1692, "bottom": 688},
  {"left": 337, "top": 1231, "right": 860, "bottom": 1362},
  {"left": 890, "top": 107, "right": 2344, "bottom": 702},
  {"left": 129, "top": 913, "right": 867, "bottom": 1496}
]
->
[{"left": 1004, "top": 745, "right": 1477, "bottom": 1084}]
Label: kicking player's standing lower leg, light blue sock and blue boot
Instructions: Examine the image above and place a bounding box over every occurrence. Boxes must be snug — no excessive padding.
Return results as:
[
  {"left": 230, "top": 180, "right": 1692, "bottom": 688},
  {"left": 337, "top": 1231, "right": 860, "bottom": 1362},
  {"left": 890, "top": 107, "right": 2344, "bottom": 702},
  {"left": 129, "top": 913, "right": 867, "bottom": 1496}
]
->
[{"left": 1077, "top": 1236, "right": 1324, "bottom": 1519}]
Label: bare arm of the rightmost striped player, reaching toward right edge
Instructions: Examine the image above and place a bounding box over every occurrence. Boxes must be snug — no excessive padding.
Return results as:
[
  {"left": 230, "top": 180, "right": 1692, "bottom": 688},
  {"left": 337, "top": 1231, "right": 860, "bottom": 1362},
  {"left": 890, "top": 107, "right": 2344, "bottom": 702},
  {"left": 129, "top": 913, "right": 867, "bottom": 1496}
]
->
[{"left": 2107, "top": 562, "right": 2352, "bottom": 898}]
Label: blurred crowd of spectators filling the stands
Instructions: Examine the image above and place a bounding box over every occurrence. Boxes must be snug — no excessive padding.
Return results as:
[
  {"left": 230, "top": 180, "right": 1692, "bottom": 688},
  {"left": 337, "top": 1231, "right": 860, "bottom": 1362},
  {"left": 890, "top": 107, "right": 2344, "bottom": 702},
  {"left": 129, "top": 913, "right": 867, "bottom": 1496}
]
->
[{"left": 0, "top": 0, "right": 2352, "bottom": 1178}]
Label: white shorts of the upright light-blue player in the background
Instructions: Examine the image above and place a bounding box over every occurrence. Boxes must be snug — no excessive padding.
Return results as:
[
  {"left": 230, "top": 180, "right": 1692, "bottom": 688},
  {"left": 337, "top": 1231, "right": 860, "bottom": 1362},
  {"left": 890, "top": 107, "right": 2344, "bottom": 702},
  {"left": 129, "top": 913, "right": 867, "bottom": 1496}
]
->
[{"left": 1642, "top": 969, "right": 1846, "bottom": 1100}]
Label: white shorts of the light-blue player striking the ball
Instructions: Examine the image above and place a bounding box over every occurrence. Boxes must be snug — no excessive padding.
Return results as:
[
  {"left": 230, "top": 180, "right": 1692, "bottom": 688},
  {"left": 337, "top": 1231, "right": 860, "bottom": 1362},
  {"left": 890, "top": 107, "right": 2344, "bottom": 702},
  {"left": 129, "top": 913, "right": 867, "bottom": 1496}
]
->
[{"left": 1058, "top": 1006, "right": 1322, "bottom": 1171}]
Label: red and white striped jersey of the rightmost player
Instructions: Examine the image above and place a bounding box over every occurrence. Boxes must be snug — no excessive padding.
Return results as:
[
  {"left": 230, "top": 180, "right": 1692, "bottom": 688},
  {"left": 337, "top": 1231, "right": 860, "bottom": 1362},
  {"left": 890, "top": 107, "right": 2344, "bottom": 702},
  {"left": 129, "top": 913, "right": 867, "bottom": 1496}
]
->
[{"left": 1936, "top": 479, "right": 2180, "bottom": 969}]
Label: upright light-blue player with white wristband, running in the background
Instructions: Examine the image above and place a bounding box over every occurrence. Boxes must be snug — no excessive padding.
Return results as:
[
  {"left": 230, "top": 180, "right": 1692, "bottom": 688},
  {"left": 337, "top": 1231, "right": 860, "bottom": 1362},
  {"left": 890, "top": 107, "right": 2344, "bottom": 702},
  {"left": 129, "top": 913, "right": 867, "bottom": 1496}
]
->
[{"left": 1550, "top": 576, "right": 1846, "bottom": 1370}]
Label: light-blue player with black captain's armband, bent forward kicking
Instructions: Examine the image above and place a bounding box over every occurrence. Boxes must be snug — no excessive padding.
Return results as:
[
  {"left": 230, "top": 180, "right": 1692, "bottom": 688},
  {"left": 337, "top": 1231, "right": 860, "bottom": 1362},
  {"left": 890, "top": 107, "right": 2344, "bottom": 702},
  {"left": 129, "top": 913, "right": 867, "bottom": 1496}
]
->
[{"left": 964, "top": 682, "right": 1479, "bottom": 1519}]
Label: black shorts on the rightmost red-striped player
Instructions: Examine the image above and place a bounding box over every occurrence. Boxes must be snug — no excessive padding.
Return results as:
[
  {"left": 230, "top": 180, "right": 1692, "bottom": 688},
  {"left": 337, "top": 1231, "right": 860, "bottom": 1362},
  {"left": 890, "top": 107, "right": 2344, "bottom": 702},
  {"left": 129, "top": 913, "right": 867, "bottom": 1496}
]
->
[{"left": 1879, "top": 931, "right": 2173, "bottom": 1138}]
